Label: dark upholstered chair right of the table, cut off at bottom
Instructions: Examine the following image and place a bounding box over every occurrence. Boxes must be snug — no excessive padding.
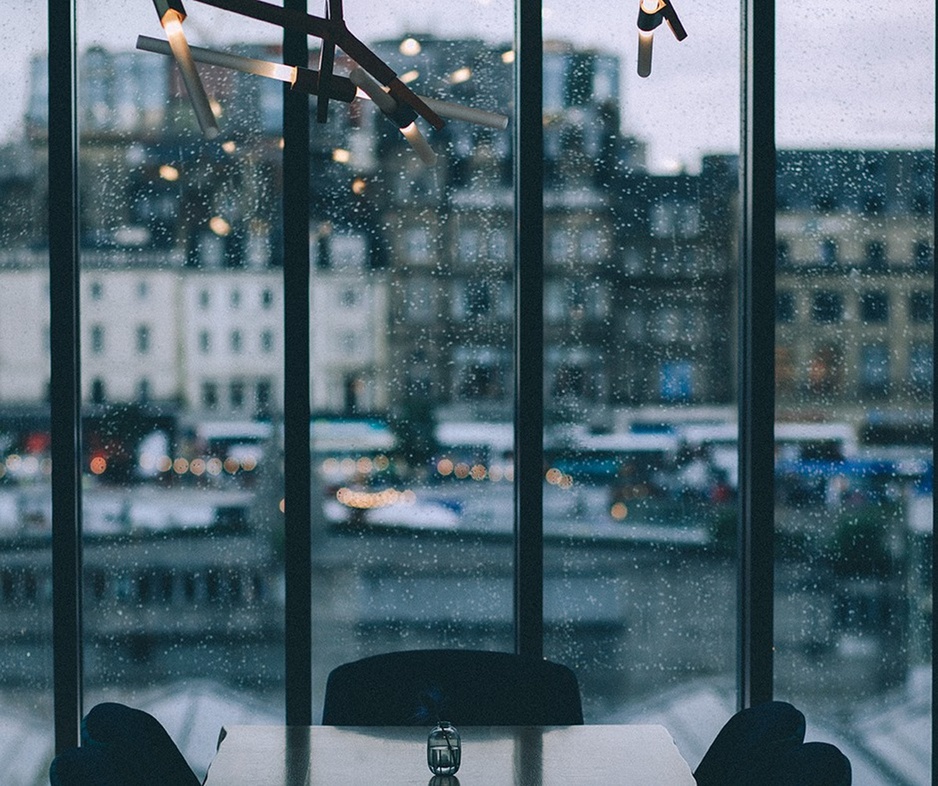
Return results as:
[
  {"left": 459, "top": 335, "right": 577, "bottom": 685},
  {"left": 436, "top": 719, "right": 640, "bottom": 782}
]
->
[{"left": 694, "top": 701, "right": 852, "bottom": 786}]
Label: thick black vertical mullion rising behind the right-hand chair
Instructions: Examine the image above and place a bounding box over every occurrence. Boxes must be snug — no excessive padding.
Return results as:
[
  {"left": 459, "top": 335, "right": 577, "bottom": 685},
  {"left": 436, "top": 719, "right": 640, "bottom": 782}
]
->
[{"left": 737, "top": 0, "right": 776, "bottom": 707}]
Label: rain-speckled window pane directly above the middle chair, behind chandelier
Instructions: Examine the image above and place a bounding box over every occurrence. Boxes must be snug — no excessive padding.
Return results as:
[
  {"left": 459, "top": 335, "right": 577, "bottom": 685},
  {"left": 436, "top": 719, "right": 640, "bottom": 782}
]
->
[{"left": 310, "top": 7, "right": 514, "bottom": 717}]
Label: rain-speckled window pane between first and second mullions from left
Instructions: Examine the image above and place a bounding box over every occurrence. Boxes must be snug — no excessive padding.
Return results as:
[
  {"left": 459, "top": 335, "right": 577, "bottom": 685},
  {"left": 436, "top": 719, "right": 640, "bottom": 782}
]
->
[{"left": 78, "top": 0, "right": 284, "bottom": 772}]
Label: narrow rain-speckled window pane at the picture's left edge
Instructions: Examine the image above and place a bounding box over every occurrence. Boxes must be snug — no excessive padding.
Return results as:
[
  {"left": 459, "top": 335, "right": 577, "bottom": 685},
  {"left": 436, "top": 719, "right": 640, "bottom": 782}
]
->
[{"left": 0, "top": 0, "right": 53, "bottom": 786}]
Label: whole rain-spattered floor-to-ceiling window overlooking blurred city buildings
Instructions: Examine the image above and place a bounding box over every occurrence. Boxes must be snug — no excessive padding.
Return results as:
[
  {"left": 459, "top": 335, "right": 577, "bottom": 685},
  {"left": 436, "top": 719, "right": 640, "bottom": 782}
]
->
[{"left": 0, "top": 0, "right": 934, "bottom": 786}]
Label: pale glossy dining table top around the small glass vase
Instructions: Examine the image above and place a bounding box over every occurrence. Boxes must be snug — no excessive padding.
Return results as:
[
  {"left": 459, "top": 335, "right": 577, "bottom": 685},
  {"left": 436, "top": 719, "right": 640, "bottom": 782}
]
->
[{"left": 204, "top": 724, "right": 695, "bottom": 786}]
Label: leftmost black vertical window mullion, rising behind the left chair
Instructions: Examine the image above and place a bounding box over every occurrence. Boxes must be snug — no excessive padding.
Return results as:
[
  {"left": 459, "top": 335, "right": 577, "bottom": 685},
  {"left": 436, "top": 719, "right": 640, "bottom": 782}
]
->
[{"left": 47, "top": 0, "right": 82, "bottom": 752}]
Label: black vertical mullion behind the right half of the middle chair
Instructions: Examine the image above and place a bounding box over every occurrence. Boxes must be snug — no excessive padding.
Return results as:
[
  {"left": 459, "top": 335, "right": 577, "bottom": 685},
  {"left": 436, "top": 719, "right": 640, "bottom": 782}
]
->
[{"left": 514, "top": 0, "right": 544, "bottom": 657}]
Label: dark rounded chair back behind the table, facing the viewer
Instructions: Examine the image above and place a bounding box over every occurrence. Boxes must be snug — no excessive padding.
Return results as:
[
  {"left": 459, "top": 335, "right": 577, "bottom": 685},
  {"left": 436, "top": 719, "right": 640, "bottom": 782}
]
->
[{"left": 322, "top": 650, "right": 583, "bottom": 726}]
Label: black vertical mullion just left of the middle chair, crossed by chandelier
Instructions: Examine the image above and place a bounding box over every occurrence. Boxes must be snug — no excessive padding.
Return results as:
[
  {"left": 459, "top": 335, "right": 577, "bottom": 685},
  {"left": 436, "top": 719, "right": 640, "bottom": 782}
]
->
[{"left": 283, "top": 0, "right": 313, "bottom": 726}]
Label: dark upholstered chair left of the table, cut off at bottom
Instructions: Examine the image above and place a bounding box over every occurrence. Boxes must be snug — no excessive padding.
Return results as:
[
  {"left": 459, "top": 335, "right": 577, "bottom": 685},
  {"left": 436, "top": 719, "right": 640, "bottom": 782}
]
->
[{"left": 49, "top": 702, "right": 199, "bottom": 786}]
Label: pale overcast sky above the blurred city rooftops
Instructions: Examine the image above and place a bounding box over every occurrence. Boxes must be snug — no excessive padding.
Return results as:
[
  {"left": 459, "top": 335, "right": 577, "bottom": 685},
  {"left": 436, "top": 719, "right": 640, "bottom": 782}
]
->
[{"left": 0, "top": 0, "right": 935, "bottom": 171}]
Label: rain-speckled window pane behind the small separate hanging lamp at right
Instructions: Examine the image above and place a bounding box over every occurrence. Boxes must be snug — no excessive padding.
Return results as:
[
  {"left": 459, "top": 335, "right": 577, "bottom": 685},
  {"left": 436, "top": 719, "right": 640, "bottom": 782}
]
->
[{"left": 544, "top": 4, "right": 739, "bottom": 763}]
